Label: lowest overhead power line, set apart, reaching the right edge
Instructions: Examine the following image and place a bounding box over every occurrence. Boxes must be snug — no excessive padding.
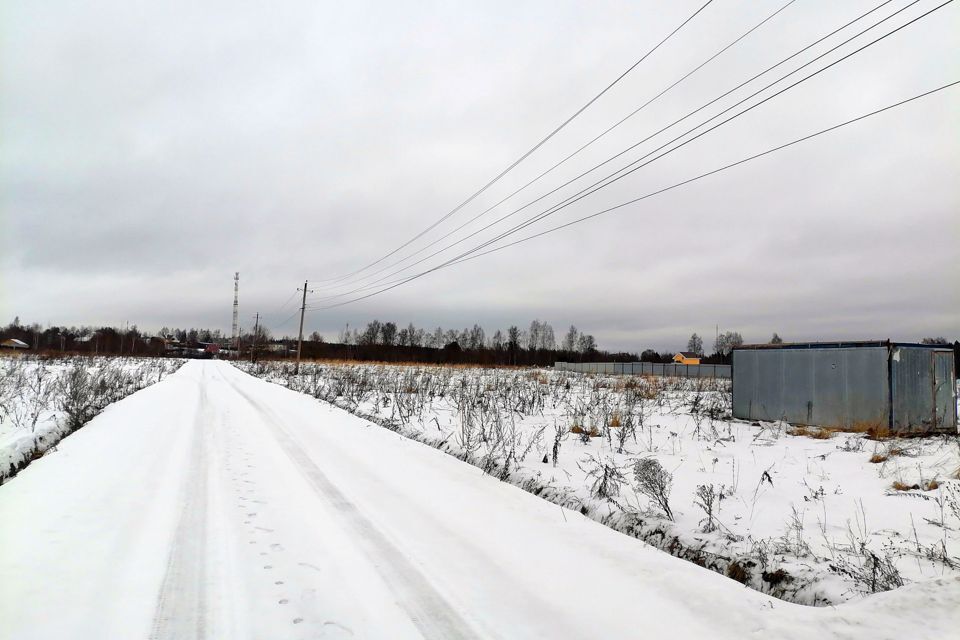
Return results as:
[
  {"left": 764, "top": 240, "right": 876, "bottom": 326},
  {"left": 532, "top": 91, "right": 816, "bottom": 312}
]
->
[{"left": 318, "top": 77, "right": 960, "bottom": 309}]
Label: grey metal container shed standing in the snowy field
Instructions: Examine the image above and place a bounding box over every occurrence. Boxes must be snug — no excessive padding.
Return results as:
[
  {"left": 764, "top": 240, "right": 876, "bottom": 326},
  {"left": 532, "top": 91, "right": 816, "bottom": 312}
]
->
[{"left": 733, "top": 340, "right": 957, "bottom": 433}]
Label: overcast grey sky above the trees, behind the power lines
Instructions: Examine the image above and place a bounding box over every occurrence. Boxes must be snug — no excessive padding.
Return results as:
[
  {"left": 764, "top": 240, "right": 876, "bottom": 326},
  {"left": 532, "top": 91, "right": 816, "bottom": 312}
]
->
[{"left": 0, "top": 0, "right": 960, "bottom": 351}]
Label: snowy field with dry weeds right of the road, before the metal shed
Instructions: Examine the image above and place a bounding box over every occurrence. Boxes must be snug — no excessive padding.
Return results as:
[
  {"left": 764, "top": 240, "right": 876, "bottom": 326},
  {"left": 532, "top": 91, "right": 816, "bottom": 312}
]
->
[{"left": 241, "top": 363, "right": 960, "bottom": 605}]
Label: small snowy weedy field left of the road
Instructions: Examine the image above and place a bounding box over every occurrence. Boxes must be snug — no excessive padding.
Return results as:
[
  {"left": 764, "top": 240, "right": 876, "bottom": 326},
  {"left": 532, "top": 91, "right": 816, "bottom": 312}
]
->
[{"left": 0, "top": 356, "right": 183, "bottom": 482}]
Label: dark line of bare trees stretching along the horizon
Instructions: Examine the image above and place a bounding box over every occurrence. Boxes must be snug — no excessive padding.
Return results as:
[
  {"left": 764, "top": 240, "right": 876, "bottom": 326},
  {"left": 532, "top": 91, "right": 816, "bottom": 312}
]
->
[{"left": 0, "top": 317, "right": 960, "bottom": 373}]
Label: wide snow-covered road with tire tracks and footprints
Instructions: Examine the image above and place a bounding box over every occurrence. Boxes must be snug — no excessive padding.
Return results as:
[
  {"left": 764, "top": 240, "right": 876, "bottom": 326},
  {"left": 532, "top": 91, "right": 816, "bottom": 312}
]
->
[{"left": 0, "top": 362, "right": 960, "bottom": 640}]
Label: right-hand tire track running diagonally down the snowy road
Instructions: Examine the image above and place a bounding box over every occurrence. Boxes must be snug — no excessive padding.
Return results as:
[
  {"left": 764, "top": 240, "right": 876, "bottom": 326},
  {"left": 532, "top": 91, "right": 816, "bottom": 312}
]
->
[{"left": 230, "top": 381, "right": 480, "bottom": 640}]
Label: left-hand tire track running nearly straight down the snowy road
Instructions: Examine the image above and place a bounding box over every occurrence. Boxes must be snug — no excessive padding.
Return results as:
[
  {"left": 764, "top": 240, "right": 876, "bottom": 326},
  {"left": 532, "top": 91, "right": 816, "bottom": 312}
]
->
[{"left": 150, "top": 383, "right": 209, "bottom": 640}]
